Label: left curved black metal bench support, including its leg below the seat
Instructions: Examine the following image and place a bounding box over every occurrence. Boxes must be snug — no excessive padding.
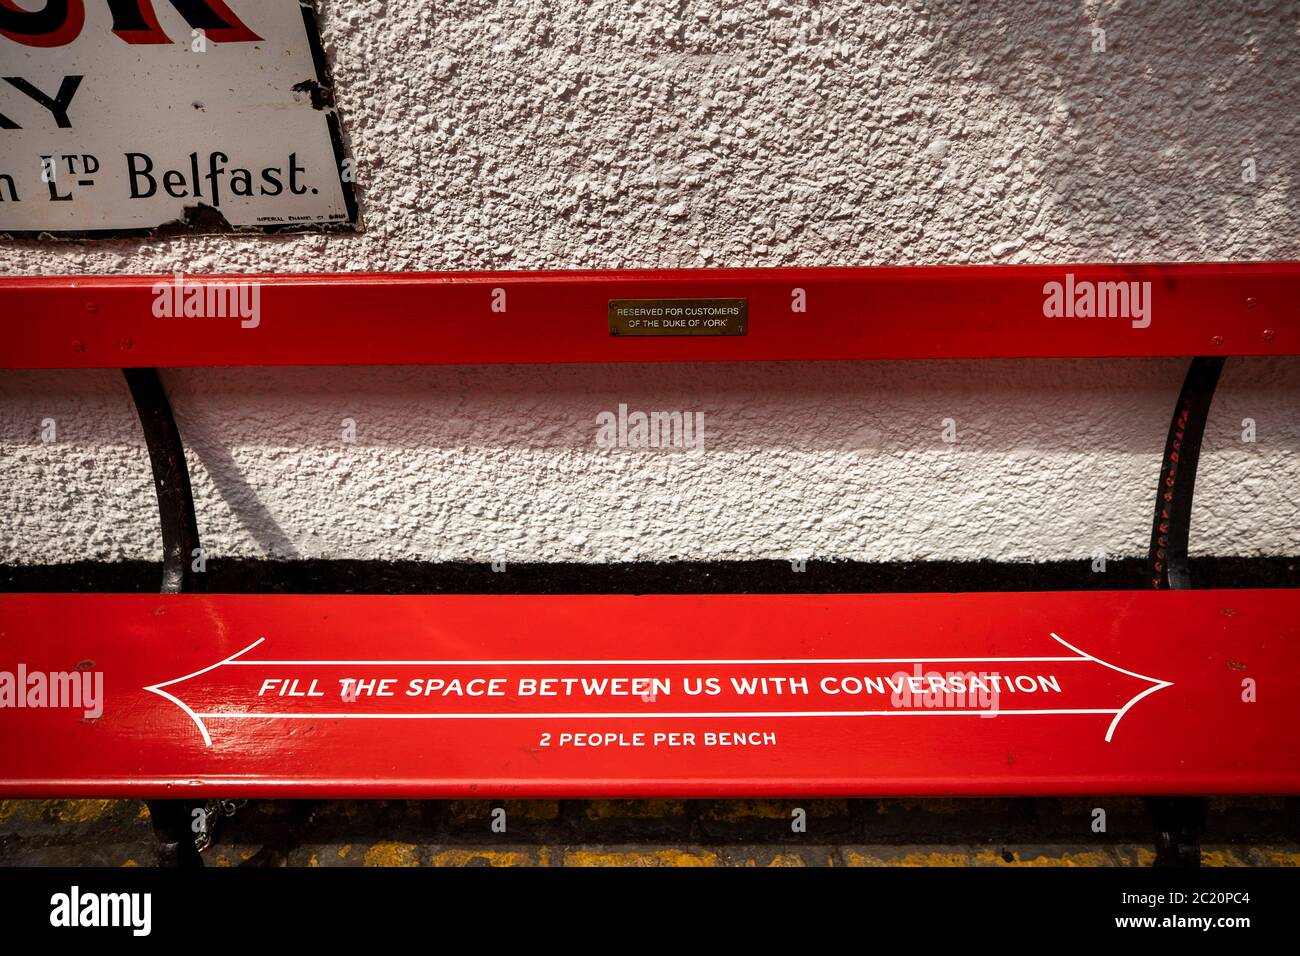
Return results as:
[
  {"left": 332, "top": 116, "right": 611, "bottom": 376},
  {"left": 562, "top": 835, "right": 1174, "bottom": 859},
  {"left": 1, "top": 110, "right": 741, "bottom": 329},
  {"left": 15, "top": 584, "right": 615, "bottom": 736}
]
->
[{"left": 122, "top": 368, "right": 204, "bottom": 866}]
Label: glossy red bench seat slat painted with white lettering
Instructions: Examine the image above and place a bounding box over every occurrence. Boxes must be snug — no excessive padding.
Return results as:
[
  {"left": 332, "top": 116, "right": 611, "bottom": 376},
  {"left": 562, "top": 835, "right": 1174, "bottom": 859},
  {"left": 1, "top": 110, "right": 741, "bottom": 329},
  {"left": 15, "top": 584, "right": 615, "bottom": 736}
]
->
[{"left": 0, "top": 589, "right": 1300, "bottom": 799}]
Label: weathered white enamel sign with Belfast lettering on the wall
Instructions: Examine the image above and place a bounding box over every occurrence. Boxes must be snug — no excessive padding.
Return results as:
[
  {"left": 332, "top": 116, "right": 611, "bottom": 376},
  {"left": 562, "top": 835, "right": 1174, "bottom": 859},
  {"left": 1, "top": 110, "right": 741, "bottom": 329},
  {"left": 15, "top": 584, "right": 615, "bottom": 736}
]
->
[{"left": 0, "top": 0, "right": 358, "bottom": 238}]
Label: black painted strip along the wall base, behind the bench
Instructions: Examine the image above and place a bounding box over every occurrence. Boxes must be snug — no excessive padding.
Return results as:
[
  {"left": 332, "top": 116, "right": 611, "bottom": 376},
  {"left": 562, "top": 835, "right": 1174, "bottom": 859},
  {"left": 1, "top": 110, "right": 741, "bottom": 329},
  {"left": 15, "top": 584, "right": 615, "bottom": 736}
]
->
[{"left": 0, "top": 555, "right": 1300, "bottom": 594}]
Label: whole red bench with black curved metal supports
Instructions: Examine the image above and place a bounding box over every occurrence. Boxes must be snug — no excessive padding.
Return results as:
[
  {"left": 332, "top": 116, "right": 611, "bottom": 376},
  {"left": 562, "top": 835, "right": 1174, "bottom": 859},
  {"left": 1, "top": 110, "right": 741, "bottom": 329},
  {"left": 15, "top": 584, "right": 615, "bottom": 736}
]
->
[{"left": 0, "top": 263, "right": 1300, "bottom": 868}]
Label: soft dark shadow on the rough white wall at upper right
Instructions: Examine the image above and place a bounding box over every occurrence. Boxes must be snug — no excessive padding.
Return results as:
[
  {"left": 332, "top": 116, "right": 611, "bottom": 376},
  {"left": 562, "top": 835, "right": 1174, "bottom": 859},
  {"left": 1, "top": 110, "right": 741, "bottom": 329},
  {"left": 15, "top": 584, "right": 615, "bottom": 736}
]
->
[{"left": 926, "top": 0, "right": 1300, "bottom": 260}]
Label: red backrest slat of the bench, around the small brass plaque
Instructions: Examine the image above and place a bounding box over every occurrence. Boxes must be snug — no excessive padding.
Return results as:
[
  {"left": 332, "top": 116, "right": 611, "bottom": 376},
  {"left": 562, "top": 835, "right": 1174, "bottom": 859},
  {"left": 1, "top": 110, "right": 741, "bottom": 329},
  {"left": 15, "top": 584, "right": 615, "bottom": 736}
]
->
[{"left": 0, "top": 263, "right": 1300, "bottom": 368}]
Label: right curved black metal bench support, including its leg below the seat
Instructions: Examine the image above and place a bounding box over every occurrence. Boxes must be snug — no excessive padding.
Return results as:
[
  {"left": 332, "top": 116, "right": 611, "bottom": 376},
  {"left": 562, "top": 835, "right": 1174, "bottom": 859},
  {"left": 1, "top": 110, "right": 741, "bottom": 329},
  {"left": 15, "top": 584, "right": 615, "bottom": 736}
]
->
[{"left": 1147, "top": 356, "right": 1223, "bottom": 866}]
